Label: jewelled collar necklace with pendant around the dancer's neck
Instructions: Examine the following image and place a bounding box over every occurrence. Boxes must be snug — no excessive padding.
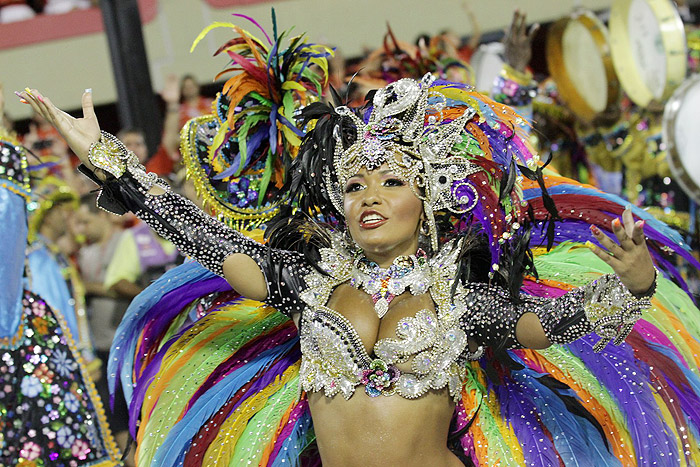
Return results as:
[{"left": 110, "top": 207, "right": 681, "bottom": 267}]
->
[{"left": 350, "top": 249, "right": 432, "bottom": 319}]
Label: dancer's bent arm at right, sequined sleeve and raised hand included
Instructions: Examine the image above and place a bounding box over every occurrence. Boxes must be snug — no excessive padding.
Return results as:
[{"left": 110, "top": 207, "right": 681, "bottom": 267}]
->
[{"left": 464, "top": 210, "right": 656, "bottom": 350}]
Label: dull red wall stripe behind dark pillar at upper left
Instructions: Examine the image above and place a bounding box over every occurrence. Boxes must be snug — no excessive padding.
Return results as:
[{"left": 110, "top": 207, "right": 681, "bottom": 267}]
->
[{"left": 0, "top": 0, "right": 158, "bottom": 50}]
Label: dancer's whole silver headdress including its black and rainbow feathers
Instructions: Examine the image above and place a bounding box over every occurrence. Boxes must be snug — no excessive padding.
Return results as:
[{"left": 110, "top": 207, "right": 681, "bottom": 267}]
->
[{"left": 288, "top": 75, "right": 541, "bottom": 273}]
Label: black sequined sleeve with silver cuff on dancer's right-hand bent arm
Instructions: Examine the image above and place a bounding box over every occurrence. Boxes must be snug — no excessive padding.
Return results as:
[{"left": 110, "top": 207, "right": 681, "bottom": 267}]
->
[{"left": 464, "top": 274, "right": 656, "bottom": 351}]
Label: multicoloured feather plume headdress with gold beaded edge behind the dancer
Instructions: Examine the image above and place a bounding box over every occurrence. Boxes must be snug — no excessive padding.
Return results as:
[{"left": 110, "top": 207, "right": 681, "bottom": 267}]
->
[{"left": 181, "top": 9, "right": 333, "bottom": 230}]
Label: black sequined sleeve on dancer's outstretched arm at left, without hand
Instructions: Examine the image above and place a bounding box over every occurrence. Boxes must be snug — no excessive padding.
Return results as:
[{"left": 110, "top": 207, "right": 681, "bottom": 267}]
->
[{"left": 75, "top": 135, "right": 308, "bottom": 315}]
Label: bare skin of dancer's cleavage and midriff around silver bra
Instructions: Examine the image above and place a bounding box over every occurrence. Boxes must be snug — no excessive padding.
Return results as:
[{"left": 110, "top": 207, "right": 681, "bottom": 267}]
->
[{"left": 300, "top": 285, "right": 463, "bottom": 467}]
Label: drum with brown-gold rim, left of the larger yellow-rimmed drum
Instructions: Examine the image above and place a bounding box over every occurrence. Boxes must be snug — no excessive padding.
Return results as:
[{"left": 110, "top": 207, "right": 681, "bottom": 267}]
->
[{"left": 546, "top": 11, "right": 620, "bottom": 121}]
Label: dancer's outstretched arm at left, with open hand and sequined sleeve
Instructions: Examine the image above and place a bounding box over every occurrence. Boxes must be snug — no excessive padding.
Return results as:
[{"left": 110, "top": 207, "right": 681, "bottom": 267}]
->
[{"left": 21, "top": 90, "right": 307, "bottom": 314}]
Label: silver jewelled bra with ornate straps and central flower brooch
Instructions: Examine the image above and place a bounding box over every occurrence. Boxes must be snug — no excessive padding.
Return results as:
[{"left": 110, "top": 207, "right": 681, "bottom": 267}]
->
[{"left": 300, "top": 232, "right": 478, "bottom": 399}]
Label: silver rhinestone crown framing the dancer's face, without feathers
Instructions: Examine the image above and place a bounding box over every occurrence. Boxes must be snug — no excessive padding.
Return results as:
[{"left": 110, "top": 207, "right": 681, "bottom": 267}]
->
[{"left": 325, "top": 74, "right": 482, "bottom": 249}]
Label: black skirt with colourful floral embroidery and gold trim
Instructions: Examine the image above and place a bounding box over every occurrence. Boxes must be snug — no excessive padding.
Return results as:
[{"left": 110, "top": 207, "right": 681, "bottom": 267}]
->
[{"left": 0, "top": 292, "right": 120, "bottom": 467}]
